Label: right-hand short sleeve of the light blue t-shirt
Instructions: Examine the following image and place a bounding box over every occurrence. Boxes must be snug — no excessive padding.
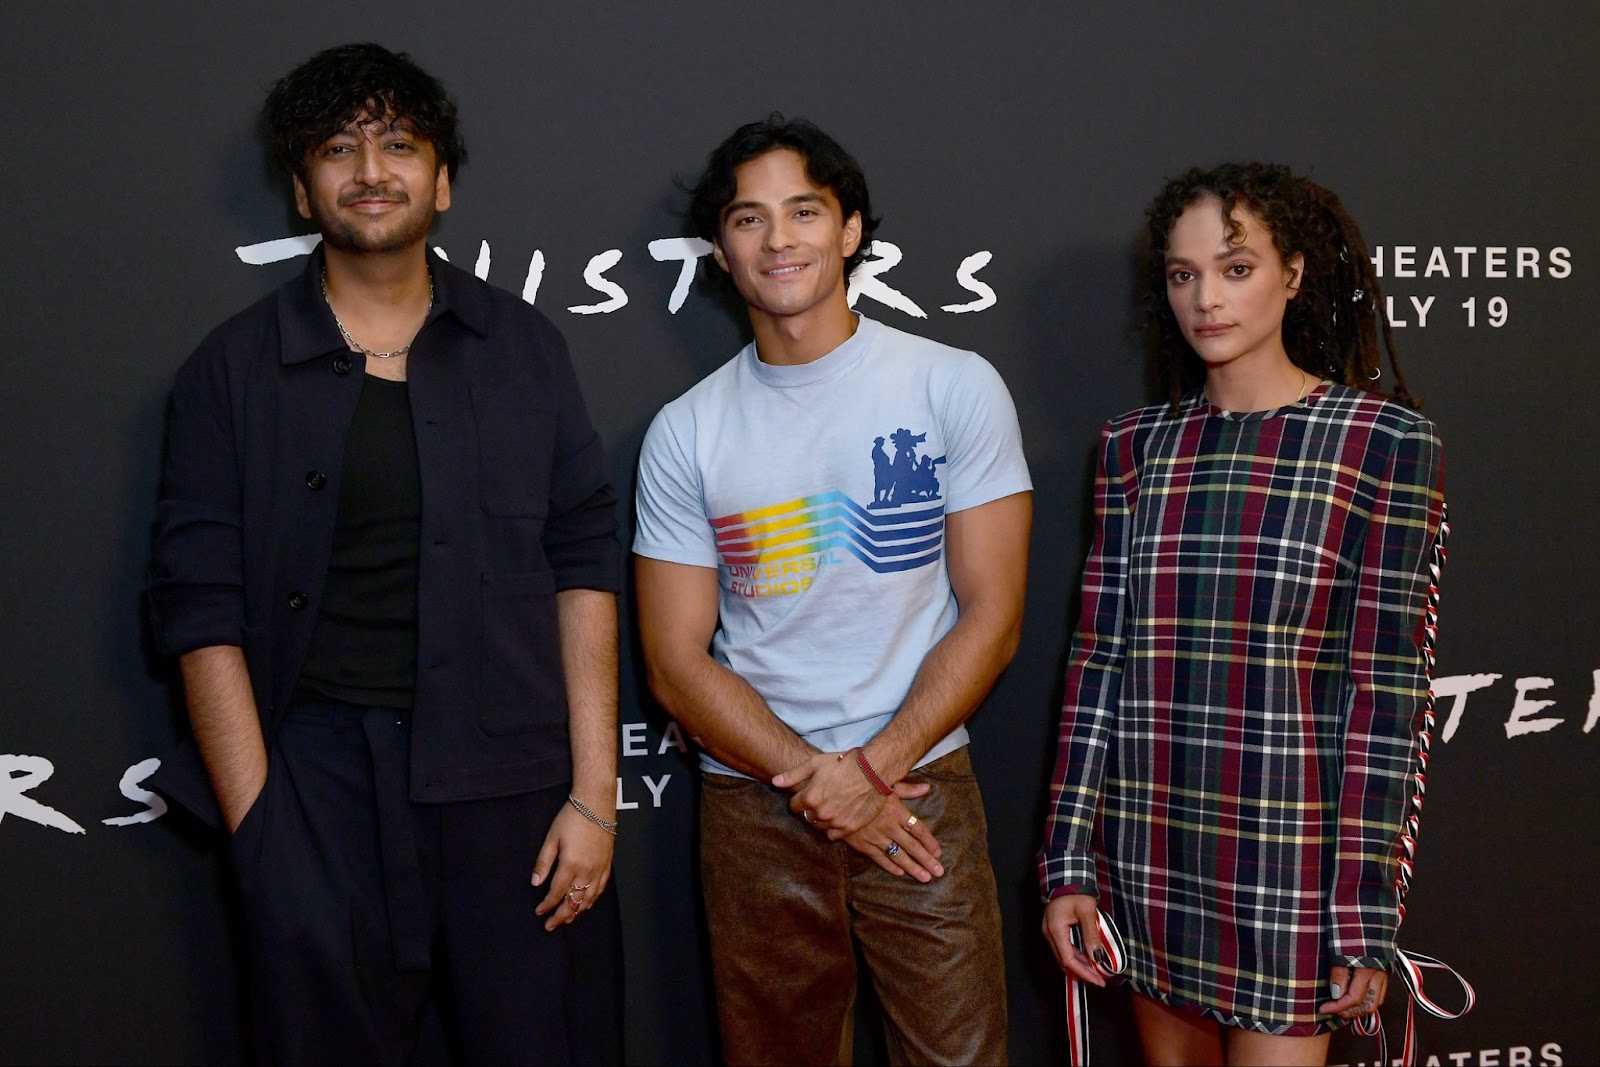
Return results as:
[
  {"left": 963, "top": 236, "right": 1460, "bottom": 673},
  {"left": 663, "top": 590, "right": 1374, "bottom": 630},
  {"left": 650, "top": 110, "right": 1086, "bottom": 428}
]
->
[{"left": 941, "top": 354, "right": 1034, "bottom": 512}]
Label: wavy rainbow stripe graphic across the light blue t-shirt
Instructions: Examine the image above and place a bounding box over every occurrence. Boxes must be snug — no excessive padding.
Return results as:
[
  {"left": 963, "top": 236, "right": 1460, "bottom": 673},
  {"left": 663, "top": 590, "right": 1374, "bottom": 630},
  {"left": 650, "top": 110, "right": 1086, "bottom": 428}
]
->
[{"left": 710, "top": 493, "right": 944, "bottom": 574}]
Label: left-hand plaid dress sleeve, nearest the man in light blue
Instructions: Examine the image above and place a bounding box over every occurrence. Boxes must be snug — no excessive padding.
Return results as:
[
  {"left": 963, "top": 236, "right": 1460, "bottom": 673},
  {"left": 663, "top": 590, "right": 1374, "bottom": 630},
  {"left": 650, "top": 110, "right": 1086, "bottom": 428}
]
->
[{"left": 1038, "top": 424, "right": 1136, "bottom": 901}]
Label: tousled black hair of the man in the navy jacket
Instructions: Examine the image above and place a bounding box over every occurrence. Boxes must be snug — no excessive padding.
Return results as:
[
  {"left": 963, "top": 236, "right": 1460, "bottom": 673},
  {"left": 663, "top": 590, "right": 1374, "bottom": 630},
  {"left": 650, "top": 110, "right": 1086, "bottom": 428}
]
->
[{"left": 261, "top": 43, "right": 467, "bottom": 181}]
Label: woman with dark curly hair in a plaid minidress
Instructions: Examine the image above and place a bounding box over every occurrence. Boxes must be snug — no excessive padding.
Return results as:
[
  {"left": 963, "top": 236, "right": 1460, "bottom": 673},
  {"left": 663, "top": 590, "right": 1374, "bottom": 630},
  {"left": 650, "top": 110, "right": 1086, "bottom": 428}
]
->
[{"left": 1040, "top": 163, "right": 1443, "bottom": 1064}]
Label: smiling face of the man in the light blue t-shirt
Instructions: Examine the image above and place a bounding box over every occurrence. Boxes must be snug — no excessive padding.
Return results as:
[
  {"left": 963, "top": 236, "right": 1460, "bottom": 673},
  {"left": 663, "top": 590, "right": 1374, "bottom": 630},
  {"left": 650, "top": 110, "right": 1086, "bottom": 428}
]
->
[{"left": 714, "top": 149, "right": 861, "bottom": 336}]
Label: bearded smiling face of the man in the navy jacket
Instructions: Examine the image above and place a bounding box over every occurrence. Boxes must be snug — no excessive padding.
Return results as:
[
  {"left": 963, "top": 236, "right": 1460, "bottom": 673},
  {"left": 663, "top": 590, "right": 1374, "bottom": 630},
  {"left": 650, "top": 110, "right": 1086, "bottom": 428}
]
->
[{"left": 294, "top": 115, "right": 450, "bottom": 254}]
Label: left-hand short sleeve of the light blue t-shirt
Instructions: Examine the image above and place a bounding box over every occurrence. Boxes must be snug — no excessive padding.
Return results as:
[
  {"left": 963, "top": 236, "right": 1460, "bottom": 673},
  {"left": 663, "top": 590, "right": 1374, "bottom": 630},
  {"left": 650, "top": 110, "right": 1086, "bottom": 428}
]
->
[{"left": 634, "top": 408, "right": 717, "bottom": 566}]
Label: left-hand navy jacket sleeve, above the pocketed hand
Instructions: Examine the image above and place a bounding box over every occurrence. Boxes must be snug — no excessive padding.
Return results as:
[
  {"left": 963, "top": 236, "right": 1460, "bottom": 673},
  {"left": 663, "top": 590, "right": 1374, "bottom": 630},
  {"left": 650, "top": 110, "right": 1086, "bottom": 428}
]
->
[{"left": 146, "top": 347, "right": 245, "bottom": 656}]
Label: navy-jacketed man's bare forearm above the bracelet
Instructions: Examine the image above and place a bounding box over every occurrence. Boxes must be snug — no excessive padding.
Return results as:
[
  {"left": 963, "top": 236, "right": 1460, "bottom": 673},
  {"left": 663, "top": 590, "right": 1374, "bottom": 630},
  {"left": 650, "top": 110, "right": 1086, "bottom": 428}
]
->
[{"left": 555, "top": 589, "right": 616, "bottom": 819}]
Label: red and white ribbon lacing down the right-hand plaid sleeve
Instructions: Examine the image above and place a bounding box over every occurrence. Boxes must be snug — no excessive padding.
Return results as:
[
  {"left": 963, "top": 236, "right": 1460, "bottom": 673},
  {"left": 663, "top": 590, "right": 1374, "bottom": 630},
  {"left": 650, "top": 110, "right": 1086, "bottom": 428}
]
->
[{"left": 1355, "top": 507, "right": 1478, "bottom": 1067}]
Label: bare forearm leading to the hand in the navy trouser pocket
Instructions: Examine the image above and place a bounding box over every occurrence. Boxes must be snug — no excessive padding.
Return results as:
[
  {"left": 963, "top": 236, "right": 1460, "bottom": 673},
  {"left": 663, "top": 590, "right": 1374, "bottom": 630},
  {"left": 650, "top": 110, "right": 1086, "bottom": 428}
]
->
[{"left": 178, "top": 645, "right": 267, "bottom": 832}]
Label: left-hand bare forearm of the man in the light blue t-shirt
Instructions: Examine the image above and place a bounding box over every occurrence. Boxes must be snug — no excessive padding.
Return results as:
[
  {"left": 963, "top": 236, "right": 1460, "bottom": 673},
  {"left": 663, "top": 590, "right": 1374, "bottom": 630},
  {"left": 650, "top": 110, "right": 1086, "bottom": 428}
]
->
[{"left": 650, "top": 653, "right": 816, "bottom": 782}]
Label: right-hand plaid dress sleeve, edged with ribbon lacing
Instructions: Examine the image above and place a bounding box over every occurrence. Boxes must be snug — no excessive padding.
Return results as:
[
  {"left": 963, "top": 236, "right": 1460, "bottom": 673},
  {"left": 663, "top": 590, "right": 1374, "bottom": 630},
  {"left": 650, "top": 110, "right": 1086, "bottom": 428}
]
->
[{"left": 1330, "top": 421, "right": 1445, "bottom": 968}]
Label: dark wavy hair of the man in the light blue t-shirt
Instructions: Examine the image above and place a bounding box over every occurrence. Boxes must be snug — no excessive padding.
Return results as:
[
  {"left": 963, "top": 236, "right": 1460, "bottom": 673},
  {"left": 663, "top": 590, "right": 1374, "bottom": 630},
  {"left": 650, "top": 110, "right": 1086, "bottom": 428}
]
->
[{"left": 690, "top": 110, "right": 882, "bottom": 278}]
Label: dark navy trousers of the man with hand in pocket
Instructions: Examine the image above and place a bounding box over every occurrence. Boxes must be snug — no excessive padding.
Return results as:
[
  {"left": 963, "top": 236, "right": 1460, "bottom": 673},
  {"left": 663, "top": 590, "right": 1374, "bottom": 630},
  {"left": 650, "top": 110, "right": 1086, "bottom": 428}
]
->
[{"left": 229, "top": 701, "right": 622, "bottom": 1065}]
